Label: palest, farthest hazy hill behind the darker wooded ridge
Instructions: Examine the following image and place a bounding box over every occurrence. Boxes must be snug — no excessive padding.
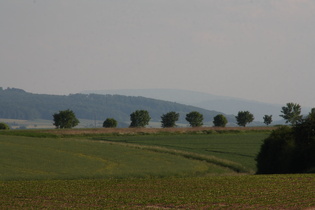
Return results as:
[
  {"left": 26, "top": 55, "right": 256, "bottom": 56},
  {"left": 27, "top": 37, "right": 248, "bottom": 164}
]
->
[{"left": 82, "top": 89, "right": 310, "bottom": 121}]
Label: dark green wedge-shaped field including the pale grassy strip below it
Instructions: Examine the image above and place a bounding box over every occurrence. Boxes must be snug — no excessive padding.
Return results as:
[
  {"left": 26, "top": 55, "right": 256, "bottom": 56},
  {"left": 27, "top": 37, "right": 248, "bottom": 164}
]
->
[{"left": 91, "top": 133, "right": 268, "bottom": 173}]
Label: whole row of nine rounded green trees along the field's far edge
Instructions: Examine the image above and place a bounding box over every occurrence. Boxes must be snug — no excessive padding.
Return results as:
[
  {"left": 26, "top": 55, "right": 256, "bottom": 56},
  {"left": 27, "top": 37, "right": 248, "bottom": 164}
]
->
[{"left": 53, "top": 103, "right": 302, "bottom": 128}]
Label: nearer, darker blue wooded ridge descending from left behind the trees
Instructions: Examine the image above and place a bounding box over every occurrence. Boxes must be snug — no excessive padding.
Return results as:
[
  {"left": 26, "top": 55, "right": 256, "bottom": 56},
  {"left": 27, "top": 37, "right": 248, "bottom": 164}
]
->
[{"left": 0, "top": 88, "right": 244, "bottom": 127}]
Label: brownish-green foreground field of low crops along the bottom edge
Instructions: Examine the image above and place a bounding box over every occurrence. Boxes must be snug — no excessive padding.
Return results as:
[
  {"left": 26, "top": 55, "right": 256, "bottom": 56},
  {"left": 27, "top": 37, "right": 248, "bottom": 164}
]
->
[{"left": 0, "top": 175, "right": 315, "bottom": 209}]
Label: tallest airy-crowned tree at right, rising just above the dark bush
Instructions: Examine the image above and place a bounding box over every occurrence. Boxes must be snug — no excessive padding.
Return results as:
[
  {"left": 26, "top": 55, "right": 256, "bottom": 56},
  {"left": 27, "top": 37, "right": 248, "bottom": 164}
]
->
[{"left": 280, "top": 103, "right": 302, "bottom": 125}]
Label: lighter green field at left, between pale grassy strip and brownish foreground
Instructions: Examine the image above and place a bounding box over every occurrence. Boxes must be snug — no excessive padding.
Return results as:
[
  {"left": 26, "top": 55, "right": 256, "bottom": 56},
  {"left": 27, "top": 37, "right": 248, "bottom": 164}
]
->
[{"left": 0, "top": 136, "right": 233, "bottom": 180}]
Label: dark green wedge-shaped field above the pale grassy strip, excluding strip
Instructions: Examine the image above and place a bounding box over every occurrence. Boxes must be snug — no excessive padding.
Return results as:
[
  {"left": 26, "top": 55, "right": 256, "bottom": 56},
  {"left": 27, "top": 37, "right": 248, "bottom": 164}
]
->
[{"left": 95, "top": 132, "right": 269, "bottom": 172}]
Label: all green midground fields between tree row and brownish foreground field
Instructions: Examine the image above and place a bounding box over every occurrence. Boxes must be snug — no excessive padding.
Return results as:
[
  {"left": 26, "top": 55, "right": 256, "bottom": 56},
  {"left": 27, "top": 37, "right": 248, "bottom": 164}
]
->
[{"left": 0, "top": 129, "right": 268, "bottom": 180}]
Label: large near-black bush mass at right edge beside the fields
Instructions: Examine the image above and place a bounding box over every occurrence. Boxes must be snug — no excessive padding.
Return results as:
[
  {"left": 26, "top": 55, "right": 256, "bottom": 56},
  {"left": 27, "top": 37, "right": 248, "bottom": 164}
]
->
[{"left": 256, "top": 113, "right": 315, "bottom": 174}]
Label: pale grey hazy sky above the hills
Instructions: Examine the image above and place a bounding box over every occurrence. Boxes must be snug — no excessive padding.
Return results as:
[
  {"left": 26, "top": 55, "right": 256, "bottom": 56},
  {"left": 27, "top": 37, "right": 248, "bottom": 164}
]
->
[{"left": 0, "top": 0, "right": 315, "bottom": 107}]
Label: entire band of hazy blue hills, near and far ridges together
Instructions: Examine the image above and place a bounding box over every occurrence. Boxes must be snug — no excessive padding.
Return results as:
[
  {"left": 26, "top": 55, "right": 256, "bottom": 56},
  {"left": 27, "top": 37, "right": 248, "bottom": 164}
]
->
[{"left": 0, "top": 88, "right": 310, "bottom": 127}]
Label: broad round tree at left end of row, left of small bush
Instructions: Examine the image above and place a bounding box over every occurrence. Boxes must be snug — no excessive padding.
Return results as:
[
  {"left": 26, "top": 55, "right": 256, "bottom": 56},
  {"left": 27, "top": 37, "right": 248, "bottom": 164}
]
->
[{"left": 53, "top": 109, "right": 80, "bottom": 128}]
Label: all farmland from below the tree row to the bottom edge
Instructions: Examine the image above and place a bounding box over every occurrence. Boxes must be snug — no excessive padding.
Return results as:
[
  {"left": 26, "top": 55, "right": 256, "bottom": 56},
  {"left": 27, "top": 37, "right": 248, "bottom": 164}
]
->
[{"left": 0, "top": 128, "right": 315, "bottom": 209}]
